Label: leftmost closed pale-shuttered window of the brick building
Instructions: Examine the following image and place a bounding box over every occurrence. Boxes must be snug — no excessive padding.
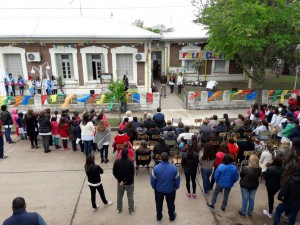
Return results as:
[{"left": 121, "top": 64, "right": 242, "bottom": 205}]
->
[{"left": 4, "top": 54, "right": 23, "bottom": 77}]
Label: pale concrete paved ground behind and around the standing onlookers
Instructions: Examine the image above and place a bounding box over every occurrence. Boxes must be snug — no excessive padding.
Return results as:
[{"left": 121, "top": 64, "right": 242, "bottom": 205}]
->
[{"left": 0, "top": 131, "right": 300, "bottom": 225}]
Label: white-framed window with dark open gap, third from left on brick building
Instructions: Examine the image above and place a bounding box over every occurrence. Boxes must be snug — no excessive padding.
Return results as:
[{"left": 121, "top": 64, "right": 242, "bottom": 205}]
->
[{"left": 86, "top": 54, "right": 105, "bottom": 80}]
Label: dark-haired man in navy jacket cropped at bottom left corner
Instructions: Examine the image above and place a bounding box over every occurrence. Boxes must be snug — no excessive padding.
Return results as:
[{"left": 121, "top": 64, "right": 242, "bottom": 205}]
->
[{"left": 3, "top": 197, "right": 46, "bottom": 225}]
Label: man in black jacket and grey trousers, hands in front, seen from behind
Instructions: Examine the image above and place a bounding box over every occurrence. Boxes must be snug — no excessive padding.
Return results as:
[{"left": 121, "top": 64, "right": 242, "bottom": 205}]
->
[{"left": 113, "top": 149, "right": 135, "bottom": 214}]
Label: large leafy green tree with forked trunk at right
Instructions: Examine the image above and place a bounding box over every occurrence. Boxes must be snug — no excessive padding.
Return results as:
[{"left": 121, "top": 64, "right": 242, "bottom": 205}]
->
[{"left": 193, "top": 0, "right": 300, "bottom": 101}]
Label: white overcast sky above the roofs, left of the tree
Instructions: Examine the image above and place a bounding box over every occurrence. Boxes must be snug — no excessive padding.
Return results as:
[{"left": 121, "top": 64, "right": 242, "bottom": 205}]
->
[{"left": 0, "top": 0, "right": 195, "bottom": 30}]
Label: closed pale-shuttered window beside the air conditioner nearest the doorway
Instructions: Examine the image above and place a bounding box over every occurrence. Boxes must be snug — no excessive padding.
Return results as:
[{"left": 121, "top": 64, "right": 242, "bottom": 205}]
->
[{"left": 116, "top": 53, "right": 133, "bottom": 80}]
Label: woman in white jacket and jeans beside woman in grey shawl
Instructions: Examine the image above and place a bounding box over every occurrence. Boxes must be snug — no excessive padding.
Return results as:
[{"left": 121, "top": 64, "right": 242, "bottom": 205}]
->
[{"left": 80, "top": 113, "right": 95, "bottom": 156}]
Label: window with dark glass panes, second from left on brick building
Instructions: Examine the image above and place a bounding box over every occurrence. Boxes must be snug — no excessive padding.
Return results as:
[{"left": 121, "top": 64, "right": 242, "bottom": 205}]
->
[{"left": 56, "top": 54, "right": 75, "bottom": 80}]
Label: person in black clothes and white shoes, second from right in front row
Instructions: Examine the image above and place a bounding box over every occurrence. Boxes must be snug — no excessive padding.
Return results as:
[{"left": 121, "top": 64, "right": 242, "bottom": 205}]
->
[{"left": 263, "top": 156, "right": 283, "bottom": 218}]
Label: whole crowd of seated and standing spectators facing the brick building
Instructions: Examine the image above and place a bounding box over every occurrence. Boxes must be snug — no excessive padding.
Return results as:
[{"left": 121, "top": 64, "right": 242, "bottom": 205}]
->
[{"left": 0, "top": 99, "right": 300, "bottom": 225}]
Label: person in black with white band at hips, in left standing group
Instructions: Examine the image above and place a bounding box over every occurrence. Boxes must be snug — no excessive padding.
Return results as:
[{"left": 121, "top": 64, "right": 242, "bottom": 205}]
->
[{"left": 38, "top": 110, "right": 51, "bottom": 153}]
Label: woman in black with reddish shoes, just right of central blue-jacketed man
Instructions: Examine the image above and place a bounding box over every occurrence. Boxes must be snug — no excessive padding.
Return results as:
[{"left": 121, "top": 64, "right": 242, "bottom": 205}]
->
[{"left": 181, "top": 144, "right": 199, "bottom": 198}]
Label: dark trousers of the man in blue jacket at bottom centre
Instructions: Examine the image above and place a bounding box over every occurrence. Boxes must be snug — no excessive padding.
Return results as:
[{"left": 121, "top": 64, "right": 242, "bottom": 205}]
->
[{"left": 155, "top": 190, "right": 176, "bottom": 220}]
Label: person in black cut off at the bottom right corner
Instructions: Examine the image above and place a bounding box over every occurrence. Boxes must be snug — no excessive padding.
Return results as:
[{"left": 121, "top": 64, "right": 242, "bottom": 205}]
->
[{"left": 274, "top": 162, "right": 300, "bottom": 225}]
